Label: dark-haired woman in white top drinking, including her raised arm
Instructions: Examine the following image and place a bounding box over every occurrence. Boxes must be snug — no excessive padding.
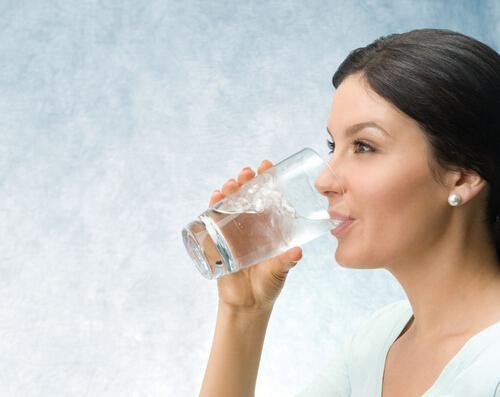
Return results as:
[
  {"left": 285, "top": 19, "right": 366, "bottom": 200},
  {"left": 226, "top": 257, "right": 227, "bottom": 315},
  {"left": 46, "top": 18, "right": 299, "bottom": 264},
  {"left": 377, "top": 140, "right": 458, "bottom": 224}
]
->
[{"left": 197, "top": 29, "right": 500, "bottom": 397}]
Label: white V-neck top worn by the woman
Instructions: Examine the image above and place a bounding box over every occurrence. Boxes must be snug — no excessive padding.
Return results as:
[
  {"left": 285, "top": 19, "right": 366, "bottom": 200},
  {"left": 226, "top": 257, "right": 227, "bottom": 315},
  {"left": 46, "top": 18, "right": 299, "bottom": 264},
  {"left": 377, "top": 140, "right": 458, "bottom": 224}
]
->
[{"left": 297, "top": 299, "right": 500, "bottom": 397}]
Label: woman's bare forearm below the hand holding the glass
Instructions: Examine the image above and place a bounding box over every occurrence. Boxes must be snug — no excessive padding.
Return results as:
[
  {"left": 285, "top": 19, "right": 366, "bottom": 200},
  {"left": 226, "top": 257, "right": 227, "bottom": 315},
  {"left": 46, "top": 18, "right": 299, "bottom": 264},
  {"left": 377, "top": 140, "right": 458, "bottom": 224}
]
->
[{"left": 200, "top": 304, "right": 271, "bottom": 397}]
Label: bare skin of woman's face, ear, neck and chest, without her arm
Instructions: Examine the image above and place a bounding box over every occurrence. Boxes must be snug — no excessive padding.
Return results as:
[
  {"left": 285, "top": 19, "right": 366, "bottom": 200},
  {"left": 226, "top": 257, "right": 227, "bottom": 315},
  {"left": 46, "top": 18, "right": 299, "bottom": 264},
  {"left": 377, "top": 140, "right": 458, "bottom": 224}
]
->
[{"left": 316, "top": 74, "right": 500, "bottom": 397}]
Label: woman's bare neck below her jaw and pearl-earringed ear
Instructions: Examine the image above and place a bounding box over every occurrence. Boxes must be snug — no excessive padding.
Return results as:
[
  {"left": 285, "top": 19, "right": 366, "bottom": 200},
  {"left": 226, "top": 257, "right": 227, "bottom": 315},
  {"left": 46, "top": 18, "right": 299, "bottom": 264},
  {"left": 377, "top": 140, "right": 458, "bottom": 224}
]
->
[{"left": 387, "top": 224, "right": 500, "bottom": 339}]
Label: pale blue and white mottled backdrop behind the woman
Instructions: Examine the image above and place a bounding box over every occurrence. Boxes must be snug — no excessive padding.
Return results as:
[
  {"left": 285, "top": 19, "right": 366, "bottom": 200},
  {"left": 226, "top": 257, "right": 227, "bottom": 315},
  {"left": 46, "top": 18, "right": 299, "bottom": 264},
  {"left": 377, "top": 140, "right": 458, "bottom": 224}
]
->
[{"left": 0, "top": 0, "right": 500, "bottom": 396}]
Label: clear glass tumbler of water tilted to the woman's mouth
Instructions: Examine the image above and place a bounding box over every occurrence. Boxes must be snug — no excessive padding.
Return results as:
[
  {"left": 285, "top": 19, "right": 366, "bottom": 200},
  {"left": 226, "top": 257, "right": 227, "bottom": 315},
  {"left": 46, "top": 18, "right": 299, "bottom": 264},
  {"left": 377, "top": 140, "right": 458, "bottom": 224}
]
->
[{"left": 182, "top": 148, "right": 348, "bottom": 279}]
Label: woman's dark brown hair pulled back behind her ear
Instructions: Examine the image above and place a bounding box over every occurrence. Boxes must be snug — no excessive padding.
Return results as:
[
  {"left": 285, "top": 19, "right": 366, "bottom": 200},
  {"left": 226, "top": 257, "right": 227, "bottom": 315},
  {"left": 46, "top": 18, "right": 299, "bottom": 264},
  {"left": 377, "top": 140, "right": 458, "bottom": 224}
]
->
[{"left": 333, "top": 29, "right": 500, "bottom": 259}]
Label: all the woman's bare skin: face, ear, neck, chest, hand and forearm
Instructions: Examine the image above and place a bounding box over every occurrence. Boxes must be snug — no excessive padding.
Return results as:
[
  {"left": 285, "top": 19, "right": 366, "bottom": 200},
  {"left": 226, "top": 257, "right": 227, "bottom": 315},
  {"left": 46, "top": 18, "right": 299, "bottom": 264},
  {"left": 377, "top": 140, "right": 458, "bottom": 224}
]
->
[{"left": 200, "top": 74, "right": 500, "bottom": 397}]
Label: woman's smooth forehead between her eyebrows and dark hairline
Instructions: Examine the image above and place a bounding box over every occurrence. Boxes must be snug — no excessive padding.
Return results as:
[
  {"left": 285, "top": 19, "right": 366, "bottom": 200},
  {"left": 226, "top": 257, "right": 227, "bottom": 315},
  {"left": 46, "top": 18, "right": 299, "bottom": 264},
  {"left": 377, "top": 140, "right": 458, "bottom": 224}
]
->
[{"left": 328, "top": 74, "right": 424, "bottom": 139}]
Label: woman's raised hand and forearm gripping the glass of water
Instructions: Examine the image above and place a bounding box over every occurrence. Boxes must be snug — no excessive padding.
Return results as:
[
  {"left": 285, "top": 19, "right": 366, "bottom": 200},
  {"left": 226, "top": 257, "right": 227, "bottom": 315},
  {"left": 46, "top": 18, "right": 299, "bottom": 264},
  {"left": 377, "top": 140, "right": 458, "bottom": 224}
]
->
[{"left": 200, "top": 160, "right": 302, "bottom": 397}]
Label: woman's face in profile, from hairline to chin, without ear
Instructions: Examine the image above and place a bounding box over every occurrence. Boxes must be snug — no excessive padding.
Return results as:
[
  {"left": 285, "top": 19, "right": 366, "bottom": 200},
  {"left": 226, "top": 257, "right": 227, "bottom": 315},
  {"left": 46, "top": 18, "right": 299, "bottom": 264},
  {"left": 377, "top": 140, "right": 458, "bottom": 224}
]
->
[{"left": 316, "top": 74, "right": 451, "bottom": 268}]
